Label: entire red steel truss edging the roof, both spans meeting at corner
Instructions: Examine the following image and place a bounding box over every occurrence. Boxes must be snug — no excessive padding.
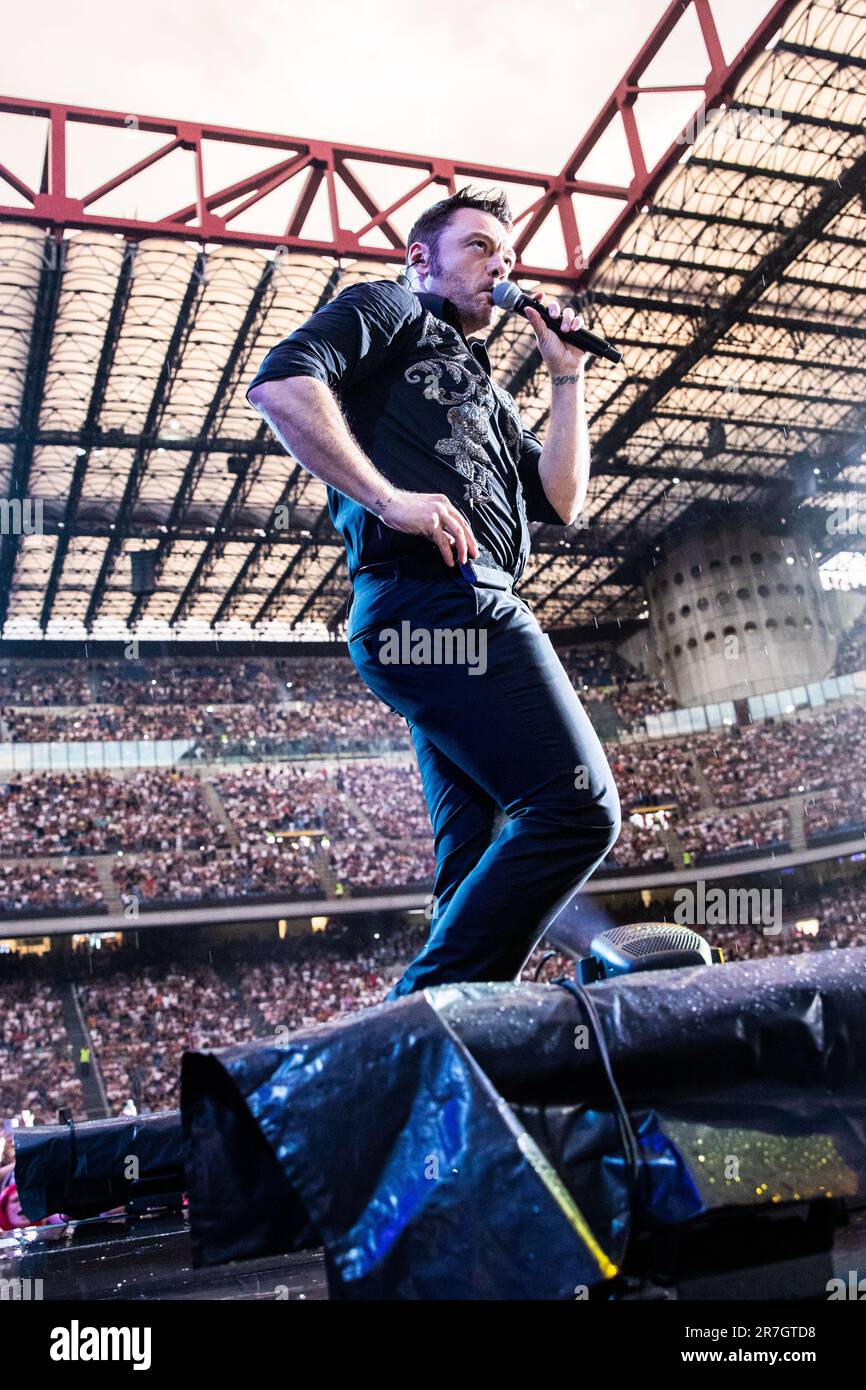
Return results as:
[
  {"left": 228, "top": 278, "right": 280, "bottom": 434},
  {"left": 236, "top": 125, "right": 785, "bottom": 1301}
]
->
[{"left": 0, "top": 0, "right": 796, "bottom": 286}]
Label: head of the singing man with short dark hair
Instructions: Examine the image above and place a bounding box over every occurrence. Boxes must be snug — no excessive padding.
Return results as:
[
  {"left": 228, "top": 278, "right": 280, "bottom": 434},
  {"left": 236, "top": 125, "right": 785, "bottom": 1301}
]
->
[{"left": 409, "top": 207, "right": 516, "bottom": 334}]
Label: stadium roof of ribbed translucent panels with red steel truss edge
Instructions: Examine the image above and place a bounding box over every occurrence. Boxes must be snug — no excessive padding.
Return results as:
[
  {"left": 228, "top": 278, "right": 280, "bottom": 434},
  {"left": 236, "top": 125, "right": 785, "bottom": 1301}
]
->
[{"left": 0, "top": 0, "right": 866, "bottom": 639}]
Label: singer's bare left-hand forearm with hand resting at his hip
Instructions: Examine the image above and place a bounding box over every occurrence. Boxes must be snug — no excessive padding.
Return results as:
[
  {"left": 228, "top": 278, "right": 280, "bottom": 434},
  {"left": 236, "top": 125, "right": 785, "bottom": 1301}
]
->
[{"left": 247, "top": 377, "right": 478, "bottom": 566}]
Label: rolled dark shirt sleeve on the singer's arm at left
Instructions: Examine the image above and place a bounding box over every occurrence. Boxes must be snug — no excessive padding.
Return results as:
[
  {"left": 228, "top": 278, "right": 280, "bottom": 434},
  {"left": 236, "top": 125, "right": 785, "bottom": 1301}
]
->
[{"left": 246, "top": 279, "right": 421, "bottom": 400}]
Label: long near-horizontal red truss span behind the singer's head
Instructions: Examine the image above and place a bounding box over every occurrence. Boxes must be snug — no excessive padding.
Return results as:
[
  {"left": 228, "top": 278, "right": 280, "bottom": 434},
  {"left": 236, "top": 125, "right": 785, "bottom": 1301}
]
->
[{"left": 0, "top": 97, "right": 608, "bottom": 281}]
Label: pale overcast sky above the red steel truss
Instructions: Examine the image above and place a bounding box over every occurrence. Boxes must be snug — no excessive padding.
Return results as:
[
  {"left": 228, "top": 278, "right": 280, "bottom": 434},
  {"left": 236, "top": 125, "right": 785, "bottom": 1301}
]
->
[{"left": 0, "top": 0, "right": 767, "bottom": 241}]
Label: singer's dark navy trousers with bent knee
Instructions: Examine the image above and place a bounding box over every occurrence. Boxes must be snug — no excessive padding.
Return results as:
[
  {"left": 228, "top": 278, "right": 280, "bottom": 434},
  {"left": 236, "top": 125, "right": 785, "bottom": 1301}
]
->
[{"left": 348, "top": 562, "right": 621, "bottom": 999}]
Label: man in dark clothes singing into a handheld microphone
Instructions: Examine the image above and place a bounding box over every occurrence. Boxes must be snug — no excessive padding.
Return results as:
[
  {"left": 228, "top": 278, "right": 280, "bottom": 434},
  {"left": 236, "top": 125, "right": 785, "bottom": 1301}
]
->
[{"left": 247, "top": 189, "right": 620, "bottom": 999}]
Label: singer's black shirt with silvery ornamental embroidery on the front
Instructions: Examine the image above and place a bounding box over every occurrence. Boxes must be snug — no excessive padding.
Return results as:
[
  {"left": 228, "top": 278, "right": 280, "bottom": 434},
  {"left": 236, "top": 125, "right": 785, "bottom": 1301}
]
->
[{"left": 247, "top": 279, "right": 564, "bottom": 578}]
